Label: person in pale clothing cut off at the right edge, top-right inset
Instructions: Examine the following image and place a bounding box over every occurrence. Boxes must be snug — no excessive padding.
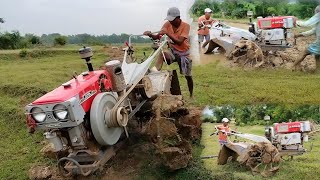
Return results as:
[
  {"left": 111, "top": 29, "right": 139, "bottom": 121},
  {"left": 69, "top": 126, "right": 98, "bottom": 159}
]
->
[{"left": 293, "top": 5, "right": 320, "bottom": 68}]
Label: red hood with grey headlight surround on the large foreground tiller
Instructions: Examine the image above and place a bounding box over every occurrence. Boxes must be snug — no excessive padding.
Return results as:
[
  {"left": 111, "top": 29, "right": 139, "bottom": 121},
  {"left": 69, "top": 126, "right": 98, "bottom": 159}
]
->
[{"left": 25, "top": 70, "right": 112, "bottom": 129}]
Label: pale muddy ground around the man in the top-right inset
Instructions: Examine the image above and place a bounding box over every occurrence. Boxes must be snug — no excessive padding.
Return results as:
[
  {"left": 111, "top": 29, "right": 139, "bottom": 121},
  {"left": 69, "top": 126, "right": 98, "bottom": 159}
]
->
[{"left": 190, "top": 23, "right": 248, "bottom": 65}]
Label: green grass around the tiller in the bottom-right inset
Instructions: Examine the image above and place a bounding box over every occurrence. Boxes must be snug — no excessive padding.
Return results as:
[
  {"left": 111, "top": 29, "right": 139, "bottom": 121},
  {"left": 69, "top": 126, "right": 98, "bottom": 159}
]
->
[{"left": 201, "top": 123, "right": 320, "bottom": 180}]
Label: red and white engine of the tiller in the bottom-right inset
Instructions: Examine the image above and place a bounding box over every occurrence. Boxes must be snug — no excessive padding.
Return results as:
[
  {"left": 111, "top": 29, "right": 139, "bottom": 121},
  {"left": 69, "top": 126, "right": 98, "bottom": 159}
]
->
[{"left": 265, "top": 121, "right": 311, "bottom": 156}]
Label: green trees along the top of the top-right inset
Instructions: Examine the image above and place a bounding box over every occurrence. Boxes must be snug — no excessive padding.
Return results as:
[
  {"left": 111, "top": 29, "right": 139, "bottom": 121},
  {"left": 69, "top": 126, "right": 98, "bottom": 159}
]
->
[{"left": 191, "top": 0, "right": 319, "bottom": 19}]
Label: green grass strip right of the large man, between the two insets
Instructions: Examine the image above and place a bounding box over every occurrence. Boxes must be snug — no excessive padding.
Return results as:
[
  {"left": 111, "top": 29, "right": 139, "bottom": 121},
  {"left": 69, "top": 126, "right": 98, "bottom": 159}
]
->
[{"left": 166, "top": 62, "right": 320, "bottom": 106}]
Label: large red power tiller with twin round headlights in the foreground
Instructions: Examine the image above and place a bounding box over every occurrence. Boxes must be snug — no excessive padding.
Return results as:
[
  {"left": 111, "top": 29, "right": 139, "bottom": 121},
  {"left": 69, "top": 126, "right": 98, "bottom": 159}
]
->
[{"left": 26, "top": 42, "right": 180, "bottom": 176}]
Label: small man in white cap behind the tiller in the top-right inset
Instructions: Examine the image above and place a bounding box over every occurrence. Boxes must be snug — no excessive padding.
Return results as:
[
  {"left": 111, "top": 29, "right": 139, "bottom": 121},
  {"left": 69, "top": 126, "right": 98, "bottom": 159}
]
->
[{"left": 198, "top": 8, "right": 215, "bottom": 47}]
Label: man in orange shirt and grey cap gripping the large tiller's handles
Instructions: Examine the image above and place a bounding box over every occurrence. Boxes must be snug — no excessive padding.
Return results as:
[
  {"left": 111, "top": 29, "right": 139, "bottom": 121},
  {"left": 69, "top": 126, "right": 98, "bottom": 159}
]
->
[{"left": 143, "top": 7, "right": 193, "bottom": 98}]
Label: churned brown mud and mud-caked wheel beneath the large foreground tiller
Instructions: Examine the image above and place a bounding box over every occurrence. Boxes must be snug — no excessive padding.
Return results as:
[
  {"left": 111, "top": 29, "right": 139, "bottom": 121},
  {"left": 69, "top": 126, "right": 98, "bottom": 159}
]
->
[{"left": 28, "top": 95, "right": 201, "bottom": 179}]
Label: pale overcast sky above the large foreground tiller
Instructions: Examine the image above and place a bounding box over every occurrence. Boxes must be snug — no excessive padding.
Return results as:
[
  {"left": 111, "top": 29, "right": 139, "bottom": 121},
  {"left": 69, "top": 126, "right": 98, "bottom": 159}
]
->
[{"left": 0, "top": 0, "right": 194, "bottom": 35}]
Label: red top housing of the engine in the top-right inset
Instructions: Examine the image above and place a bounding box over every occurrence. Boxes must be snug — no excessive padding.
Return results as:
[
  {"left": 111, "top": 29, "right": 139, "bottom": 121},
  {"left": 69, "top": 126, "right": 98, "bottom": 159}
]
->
[{"left": 258, "top": 16, "right": 296, "bottom": 29}]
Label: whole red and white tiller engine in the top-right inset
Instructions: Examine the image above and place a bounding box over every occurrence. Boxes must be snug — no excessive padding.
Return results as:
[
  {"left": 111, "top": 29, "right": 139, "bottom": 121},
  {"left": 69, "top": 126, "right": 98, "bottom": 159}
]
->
[{"left": 249, "top": 16, "right": 296, "bottom": 50}]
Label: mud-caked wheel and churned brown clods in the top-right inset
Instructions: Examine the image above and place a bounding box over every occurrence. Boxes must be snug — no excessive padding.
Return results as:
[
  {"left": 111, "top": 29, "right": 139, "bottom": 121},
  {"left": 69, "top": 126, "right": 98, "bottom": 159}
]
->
[{"left": 229, "top": 37, "right": 316, "bottom": 73}]
